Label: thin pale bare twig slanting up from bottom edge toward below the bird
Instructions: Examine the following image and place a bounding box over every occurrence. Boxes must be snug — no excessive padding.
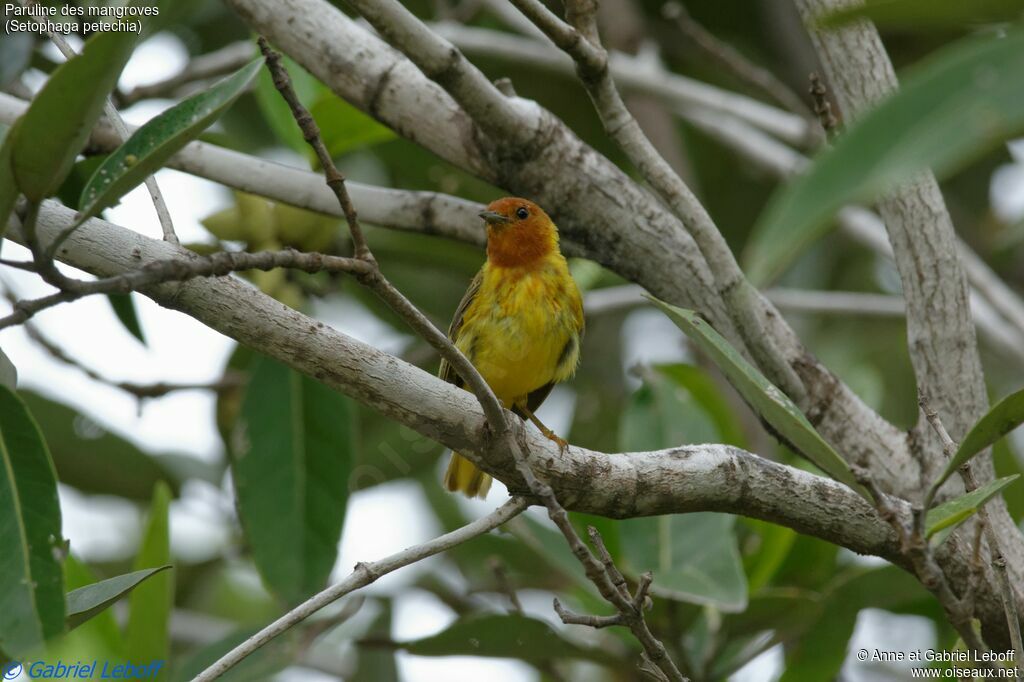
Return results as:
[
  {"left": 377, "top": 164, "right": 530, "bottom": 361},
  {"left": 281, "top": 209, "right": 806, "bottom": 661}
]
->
[{"left": 191, "top": 498, "right": 529, "bottom": 682}]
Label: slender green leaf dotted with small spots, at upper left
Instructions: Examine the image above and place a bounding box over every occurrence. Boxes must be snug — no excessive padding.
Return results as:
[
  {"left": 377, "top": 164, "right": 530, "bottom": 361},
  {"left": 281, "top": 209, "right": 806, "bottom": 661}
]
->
[{"left": 78, "top": 59, "right": 263, "bottom": 222}]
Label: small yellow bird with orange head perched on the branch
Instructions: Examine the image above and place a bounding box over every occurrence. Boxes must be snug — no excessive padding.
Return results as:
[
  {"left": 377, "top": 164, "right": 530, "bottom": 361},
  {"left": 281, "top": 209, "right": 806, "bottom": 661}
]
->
[{"left": 438, "top": 197, "right": 584, "bottom": 498}]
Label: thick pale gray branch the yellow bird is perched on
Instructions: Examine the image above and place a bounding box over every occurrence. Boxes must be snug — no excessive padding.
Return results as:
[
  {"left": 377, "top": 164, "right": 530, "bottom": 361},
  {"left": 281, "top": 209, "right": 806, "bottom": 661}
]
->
[{"left": 14, "top": 202, "right": 1019, "bottom": 645}]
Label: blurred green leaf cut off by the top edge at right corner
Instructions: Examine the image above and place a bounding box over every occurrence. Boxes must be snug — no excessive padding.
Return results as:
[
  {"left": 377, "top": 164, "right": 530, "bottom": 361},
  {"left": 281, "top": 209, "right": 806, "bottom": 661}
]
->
[{"left": 818, "top": 0, "right": 1024, "bottom": 31}]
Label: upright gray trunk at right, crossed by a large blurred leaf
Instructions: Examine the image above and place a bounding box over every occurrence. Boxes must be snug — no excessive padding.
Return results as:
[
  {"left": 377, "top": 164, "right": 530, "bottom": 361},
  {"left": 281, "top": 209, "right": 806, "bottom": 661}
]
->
[{"left": 797, "top": 0, "right": 988, "bottom": 448}]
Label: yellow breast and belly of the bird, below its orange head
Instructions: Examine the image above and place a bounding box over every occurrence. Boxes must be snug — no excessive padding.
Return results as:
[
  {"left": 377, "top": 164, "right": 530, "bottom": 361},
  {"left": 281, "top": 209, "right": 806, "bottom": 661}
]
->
[{"left": 456, "top": 253, "right": 583, "bottom": 408}]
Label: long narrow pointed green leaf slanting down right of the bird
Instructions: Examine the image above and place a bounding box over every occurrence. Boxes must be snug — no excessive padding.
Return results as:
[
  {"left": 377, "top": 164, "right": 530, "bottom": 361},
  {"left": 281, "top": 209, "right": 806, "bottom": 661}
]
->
[{"left": 650, "top": 297, "right": 867, "bottom": 498}]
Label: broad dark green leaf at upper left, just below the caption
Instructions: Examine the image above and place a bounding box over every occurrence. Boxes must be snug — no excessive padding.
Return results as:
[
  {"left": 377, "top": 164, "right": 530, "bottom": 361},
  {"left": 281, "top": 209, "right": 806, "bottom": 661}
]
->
[{"left": 11, "top": 32, "right": 136, "bottom": 202}]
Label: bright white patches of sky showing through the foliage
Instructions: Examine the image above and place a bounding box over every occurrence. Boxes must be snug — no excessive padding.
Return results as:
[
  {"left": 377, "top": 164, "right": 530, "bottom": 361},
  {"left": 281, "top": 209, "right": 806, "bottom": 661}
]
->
[{"left": 0, "top": 29, "right": 1024, "bottom": 682}]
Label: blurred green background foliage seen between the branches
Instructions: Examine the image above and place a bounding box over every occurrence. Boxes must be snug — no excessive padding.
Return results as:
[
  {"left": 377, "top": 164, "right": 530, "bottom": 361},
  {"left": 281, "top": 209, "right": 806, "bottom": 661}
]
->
[{"left": 0, "top": 0, "right": 1024, "bottom": 682}]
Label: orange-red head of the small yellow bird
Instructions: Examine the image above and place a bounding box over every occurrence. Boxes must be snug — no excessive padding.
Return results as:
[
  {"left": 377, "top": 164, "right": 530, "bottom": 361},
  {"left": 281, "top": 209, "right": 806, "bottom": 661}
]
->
[{"left": 480, "top": 197, "right": 558, "bottom": 267}]
